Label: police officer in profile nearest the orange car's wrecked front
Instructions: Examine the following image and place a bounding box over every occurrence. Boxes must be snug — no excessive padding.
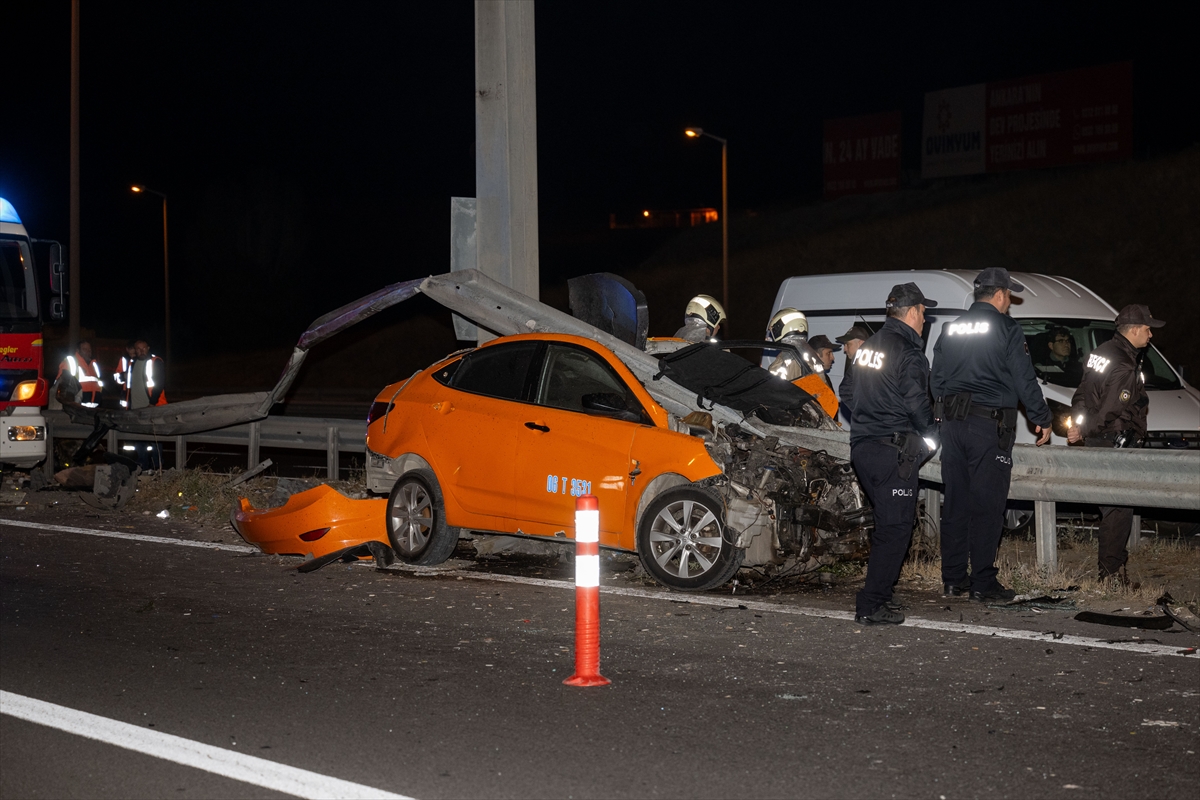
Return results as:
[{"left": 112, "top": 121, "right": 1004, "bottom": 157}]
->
[{"left": 850, "top": 283, "right": 937, "bottom": 625}]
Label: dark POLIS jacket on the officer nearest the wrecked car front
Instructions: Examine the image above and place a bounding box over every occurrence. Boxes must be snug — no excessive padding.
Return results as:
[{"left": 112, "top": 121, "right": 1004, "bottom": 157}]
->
[{"left": 850, "top": 317, "right": 937, "bottom": 445}]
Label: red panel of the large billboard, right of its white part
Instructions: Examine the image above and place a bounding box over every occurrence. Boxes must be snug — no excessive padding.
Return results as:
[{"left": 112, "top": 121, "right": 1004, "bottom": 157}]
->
[{"left": 986, "top": 62, "right": 1133, "bottom": 172}]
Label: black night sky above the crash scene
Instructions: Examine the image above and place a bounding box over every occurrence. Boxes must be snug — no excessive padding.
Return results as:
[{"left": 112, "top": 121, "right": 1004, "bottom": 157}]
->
[{"left": 0, "top": 0, "right": 1200, "bottom": 355}]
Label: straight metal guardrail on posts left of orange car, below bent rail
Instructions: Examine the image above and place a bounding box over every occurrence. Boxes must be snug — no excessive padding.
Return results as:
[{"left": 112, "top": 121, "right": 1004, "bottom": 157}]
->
[{"left": 44, "top": 411, "right": 367, "bottom": 480}]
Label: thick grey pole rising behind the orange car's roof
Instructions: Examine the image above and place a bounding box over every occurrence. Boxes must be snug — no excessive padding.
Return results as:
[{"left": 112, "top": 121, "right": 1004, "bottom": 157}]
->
[{"left": 475, "top": 0, "right": 539, "bottom": 341}]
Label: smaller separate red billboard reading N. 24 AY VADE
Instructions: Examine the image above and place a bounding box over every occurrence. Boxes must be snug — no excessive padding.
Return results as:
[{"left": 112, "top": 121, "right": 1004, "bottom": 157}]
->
[{"left": 823, "top": 112, "right": 900, "bottom": 199}]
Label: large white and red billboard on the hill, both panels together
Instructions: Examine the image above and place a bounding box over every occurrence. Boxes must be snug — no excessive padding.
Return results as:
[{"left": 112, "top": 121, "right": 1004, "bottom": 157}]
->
[{"left": 920, "top": 61, "right": 1133, "bottom": 178}]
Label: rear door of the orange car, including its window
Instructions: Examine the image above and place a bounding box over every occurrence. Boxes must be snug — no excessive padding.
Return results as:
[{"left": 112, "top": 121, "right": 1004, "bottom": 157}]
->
[{"left": 424, "top": 342, "right": 539, "bottom": 522}]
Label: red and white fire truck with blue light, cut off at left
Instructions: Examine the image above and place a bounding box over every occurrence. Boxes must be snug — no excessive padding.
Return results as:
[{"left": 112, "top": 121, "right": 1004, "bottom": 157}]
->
[{"left": 0, "top": 198, "right": 66, "bottom": 468}]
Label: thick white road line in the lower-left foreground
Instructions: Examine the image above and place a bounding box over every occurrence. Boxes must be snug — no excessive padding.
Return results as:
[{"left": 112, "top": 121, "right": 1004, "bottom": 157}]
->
[{"left": 0, "top": 691, "right": 410, "bottom": 800}]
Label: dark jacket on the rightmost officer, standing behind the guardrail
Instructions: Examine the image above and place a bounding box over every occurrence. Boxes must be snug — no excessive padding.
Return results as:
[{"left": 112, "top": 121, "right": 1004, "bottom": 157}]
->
[{"left": 1070, "top": 333, "right": 1150, "bottom": 439}]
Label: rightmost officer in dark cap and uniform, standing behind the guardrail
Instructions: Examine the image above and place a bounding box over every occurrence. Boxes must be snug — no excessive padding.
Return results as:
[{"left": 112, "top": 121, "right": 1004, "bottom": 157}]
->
[{"left": 1067, "top": 305, "right": 1165, "bottom": 584}]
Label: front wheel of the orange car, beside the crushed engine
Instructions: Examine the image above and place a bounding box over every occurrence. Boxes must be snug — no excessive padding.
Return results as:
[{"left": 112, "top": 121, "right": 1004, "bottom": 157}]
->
[{"left": 637, "top": 486, "right": 745, "bottom": 591}]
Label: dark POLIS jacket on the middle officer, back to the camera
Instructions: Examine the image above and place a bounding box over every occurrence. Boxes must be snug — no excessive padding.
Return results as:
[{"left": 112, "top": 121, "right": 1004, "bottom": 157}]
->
[{"left": 930, "top": 301, "right": 1051, "bottom": 427}]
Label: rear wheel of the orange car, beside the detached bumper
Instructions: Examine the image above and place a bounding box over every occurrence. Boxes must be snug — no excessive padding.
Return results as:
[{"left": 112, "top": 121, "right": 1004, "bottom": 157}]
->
[{"left": 385, "top": 469, "right": 458, "bottom": 565}]
